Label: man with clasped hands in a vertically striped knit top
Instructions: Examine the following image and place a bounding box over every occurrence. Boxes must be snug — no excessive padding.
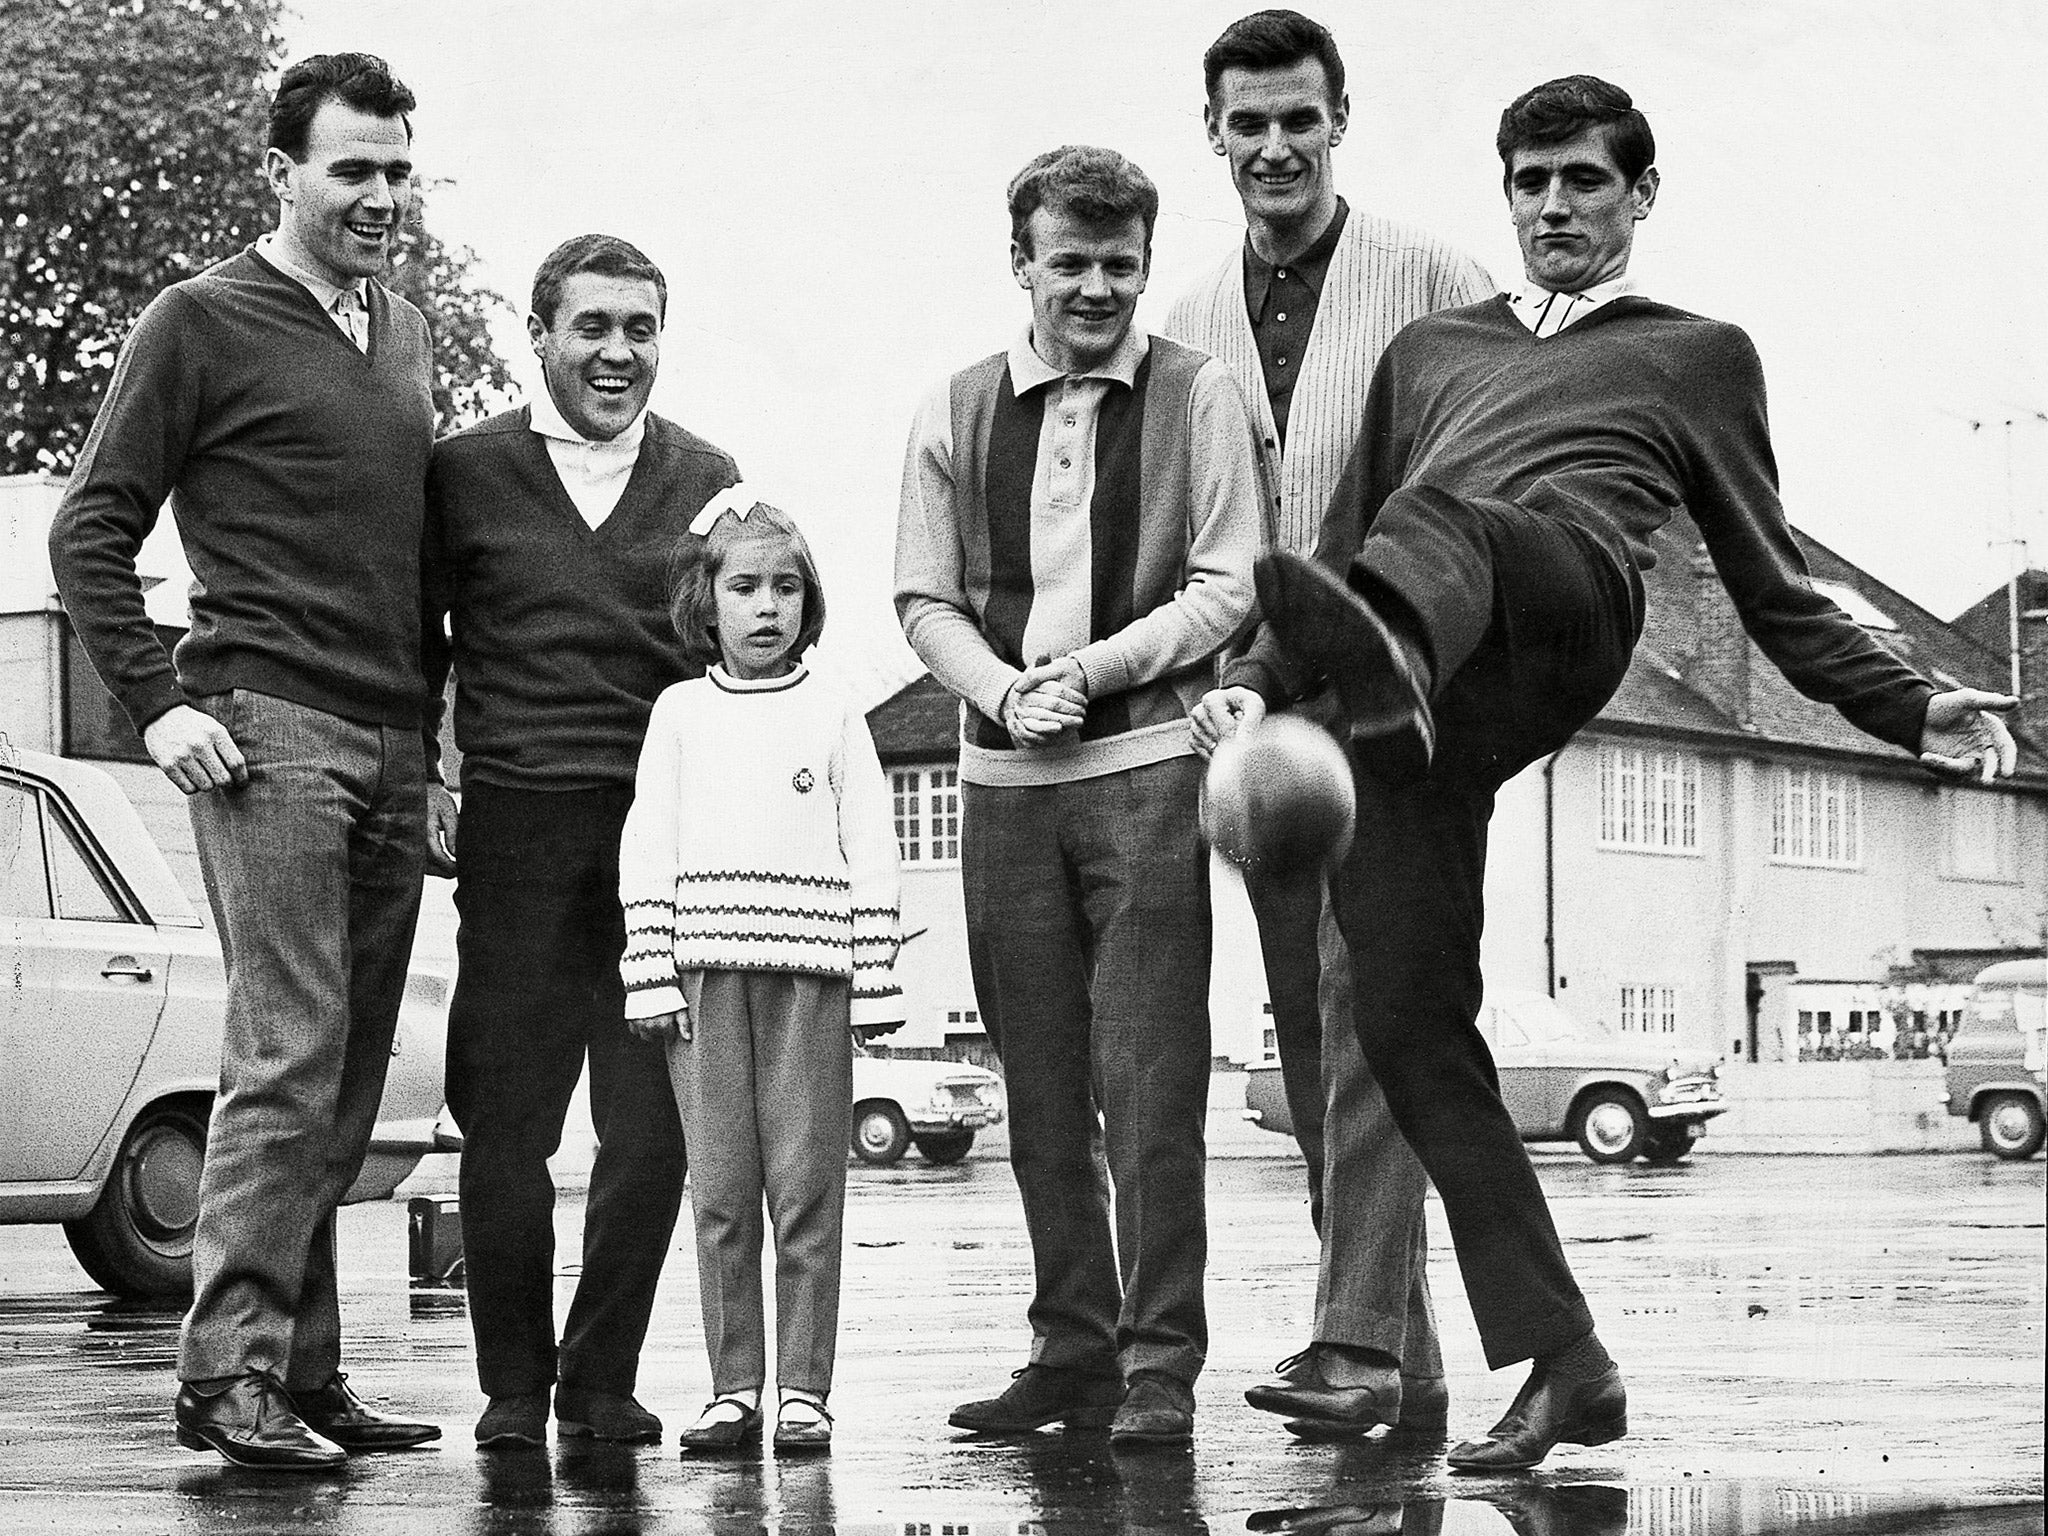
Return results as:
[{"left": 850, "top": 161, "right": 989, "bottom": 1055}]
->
[{"left": 897, "top": 147, "right": 1260, "bottom": 1446}]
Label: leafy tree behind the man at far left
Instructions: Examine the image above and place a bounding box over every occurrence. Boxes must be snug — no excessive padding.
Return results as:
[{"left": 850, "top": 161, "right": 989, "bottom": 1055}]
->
[{"left": 0, "top": 0, "right": 508, "bottom": 473}]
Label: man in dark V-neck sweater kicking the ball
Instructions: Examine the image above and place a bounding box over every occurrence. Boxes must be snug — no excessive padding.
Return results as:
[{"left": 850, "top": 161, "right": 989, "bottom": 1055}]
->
[{"left": 1219, "top": 76, "right": 2015, "bottom": 1473}]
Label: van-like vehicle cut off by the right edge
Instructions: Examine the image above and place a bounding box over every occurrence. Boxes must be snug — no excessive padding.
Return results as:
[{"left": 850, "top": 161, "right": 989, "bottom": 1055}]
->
[{"left": 1948, "top": 961, "right": 2048, "bottom": 1161}]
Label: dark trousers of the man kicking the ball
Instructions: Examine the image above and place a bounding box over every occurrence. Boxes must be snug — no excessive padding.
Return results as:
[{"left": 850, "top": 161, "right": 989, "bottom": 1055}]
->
[{"left": 1331, "top": 487, "right": 1642, "bottom": 1370}]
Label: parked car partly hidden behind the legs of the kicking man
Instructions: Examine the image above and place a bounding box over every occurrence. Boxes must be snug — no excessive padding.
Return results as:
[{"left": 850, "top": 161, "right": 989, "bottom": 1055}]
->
[{"left": 1245, "top": 991, "right": 1729, "bottom": 1163}]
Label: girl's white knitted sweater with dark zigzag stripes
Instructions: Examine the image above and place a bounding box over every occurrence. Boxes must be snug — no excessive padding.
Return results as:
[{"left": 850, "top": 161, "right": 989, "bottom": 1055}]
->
[{"left": 618, "top": 668, "right": 903, "bottom": 1026}]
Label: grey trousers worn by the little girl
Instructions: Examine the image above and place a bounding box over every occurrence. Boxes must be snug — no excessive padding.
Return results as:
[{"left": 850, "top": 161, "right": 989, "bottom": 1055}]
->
[{"left": 668, "top": 971, "right": 854, "bottom": 1395}]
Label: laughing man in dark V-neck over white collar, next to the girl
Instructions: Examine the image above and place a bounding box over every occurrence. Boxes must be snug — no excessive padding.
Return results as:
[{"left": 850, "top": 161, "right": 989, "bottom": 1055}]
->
[{"left": 424, "top": 236, "right": 737, "bottom": 1448}]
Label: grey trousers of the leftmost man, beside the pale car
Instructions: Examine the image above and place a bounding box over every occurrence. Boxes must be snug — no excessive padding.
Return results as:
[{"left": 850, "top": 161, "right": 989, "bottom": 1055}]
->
[{"left": 178, "top": 688, "right": 426, "bottom": 1391}]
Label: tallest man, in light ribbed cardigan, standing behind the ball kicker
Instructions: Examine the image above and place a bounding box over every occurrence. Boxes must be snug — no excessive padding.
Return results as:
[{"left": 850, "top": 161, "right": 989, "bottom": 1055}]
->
[{"left": 1165, "top": 10, "right": 1495, "bottom": 1434}]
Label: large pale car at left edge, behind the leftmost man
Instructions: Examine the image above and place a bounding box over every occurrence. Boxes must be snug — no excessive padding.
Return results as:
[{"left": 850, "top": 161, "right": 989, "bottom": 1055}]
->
[{"left": 0, "top": 752, "right": 461, "bottom": 1296}]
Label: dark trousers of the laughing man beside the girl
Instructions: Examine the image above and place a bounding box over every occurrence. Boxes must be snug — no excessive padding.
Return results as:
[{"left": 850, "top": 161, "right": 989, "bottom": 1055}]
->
[{"left": 449, "top": 784, "right": 684, "bottom": 1397}]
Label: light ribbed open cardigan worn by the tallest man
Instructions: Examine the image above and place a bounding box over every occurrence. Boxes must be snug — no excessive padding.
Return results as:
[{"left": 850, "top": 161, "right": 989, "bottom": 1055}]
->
[{"left": 1161, "top": 207, "right": 1497, "bottom": 553}]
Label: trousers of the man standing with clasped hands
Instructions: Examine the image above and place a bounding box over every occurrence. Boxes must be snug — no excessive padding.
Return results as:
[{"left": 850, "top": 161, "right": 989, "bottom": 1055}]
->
[{"left": 961, "top": 758, "right": 1210, "bottom": 1382}]
